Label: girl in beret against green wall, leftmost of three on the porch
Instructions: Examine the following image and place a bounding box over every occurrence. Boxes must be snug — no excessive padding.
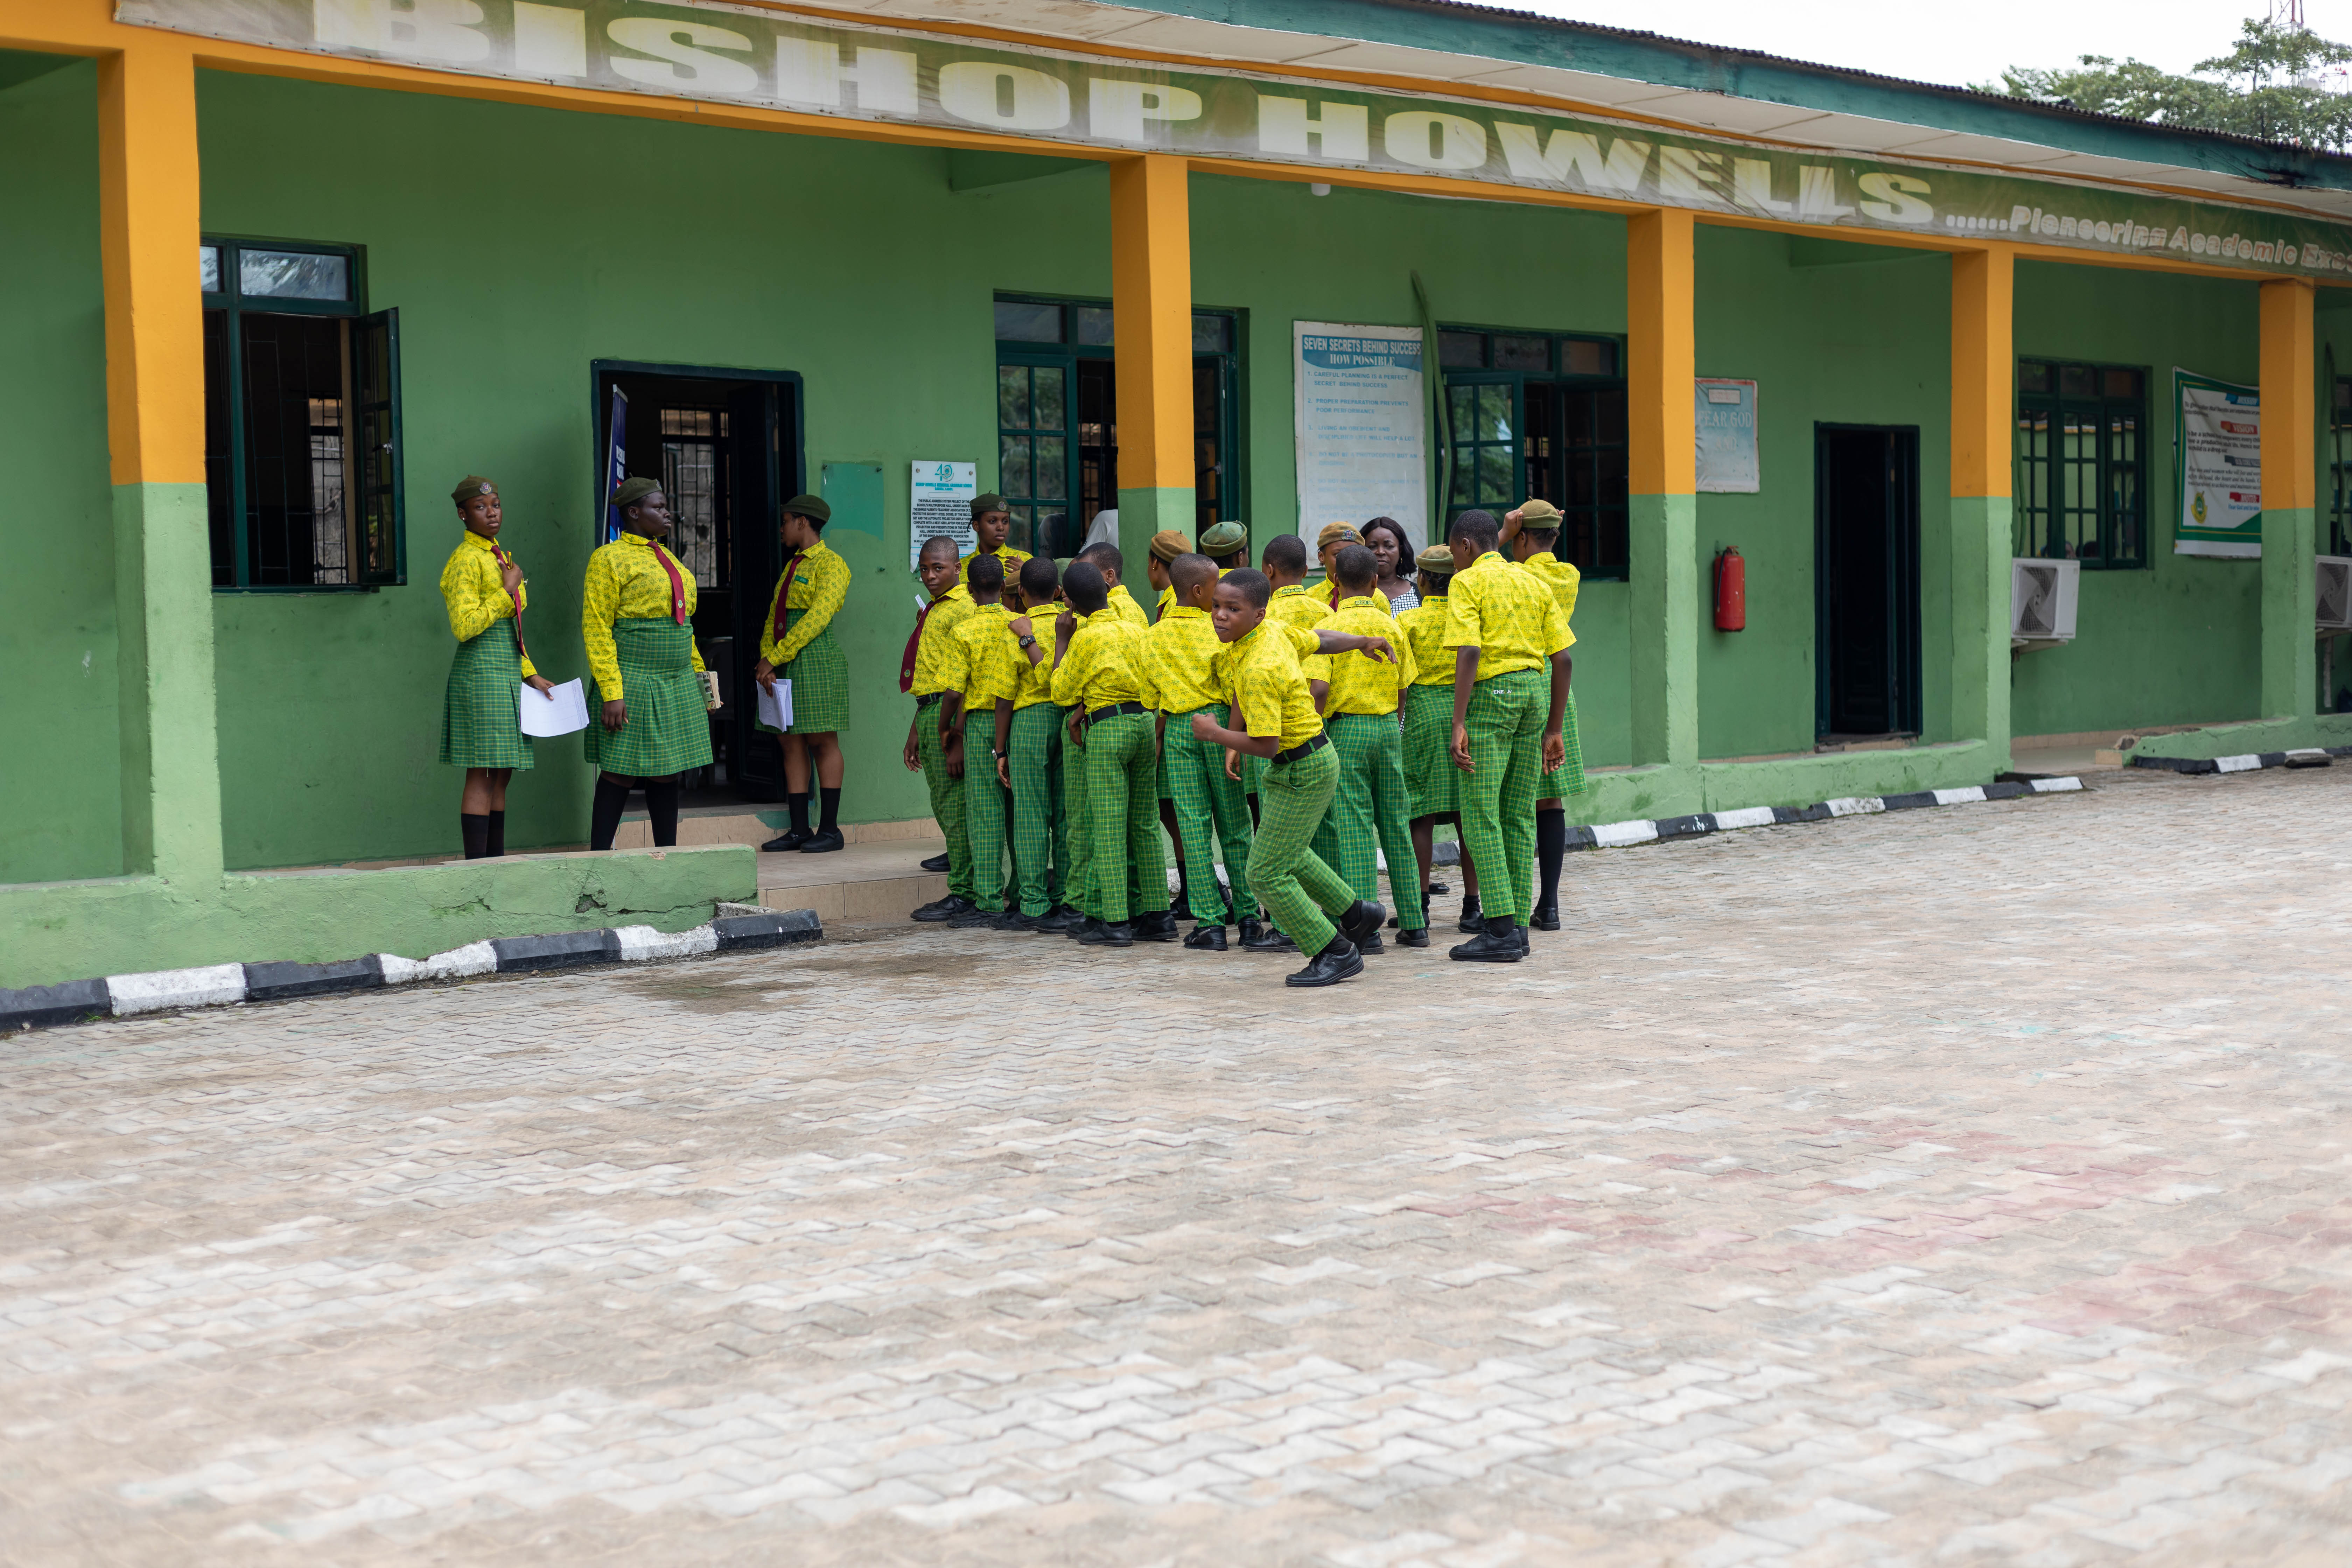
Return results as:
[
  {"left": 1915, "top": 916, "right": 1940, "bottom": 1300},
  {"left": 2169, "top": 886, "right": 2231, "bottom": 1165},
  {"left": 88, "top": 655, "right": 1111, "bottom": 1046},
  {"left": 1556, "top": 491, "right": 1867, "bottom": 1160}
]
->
[{"left": 440, "top": 475, "right": 548, "bottom": 860}]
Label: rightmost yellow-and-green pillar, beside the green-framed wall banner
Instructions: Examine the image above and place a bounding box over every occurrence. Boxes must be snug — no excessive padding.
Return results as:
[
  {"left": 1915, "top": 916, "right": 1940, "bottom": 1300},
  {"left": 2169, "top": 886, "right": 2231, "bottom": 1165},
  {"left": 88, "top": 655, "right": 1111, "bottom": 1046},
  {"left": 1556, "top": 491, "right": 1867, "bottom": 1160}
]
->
[{"left": 2263, "top": 278, "right": 2319, "bottom": 719}]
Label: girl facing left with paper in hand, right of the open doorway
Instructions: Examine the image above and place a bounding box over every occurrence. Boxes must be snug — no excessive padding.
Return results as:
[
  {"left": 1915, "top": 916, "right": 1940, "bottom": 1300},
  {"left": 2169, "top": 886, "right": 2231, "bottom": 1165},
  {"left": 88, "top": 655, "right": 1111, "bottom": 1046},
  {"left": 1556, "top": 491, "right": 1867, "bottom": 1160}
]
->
[{"left": 752, "top": 496, "right": 852, "bottom": 856}]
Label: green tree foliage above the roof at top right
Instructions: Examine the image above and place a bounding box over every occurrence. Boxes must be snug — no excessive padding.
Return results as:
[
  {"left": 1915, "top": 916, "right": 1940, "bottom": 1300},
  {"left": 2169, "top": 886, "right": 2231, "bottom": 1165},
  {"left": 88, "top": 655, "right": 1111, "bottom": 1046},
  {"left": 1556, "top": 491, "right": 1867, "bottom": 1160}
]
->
[{"left": 1985, "top": 19, "right": 2352, "bottom": 153}]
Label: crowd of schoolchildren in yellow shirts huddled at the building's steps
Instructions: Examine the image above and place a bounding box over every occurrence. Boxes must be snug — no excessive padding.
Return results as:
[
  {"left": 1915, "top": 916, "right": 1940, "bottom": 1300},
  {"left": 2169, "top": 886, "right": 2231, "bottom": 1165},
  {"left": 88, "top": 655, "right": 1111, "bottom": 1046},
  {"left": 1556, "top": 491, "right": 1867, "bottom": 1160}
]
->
[{"left": 901, "top": 496, "right": 1585, "bottom": 985}]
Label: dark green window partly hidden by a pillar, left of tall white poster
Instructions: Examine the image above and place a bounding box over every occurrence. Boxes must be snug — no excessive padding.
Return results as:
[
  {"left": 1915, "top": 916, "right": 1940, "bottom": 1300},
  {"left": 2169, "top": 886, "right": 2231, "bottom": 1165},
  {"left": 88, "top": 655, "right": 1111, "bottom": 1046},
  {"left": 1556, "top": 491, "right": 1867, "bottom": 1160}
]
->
[{"left": 995, "top": 294, "right": 1244, "bottom": 557}]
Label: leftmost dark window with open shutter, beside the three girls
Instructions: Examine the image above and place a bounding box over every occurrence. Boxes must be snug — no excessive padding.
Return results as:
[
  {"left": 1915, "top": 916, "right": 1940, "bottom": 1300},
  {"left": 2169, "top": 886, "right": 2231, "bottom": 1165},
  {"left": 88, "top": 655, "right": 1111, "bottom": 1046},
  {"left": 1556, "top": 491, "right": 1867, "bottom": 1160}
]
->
[{"left": 197, "top": 235, "right": 407, "bottom": 593}]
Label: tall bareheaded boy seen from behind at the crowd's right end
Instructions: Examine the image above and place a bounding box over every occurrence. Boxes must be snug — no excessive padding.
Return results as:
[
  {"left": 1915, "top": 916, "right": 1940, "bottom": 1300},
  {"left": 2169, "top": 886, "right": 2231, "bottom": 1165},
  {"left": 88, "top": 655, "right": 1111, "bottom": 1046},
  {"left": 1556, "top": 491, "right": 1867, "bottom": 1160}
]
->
[{"left": 1444, "top": 510, "right": 1569, "bottom": 964}]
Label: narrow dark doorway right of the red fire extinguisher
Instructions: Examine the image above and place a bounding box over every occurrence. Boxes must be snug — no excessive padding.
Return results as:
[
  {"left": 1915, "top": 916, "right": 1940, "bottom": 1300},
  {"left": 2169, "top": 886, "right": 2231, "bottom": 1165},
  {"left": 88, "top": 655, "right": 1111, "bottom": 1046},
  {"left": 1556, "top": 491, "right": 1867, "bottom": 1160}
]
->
[{"left": 1813, "top": 426, "right": 1919, "bottom": 741}]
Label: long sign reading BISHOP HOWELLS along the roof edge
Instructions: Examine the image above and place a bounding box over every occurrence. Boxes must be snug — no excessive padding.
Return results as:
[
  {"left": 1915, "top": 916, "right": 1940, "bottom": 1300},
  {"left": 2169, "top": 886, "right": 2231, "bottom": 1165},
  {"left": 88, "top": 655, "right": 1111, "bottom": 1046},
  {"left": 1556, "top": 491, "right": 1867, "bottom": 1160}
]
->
[{"left": 115, "top": 0, "right": 2352, "bottom": 278}]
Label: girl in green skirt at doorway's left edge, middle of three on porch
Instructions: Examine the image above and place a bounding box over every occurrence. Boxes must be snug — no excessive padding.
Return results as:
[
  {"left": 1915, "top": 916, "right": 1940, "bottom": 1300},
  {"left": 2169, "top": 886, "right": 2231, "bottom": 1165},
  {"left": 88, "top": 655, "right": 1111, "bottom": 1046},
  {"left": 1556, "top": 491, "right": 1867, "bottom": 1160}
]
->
[{"left": 581, "top": 479, "right": 710, "bottom": 849}]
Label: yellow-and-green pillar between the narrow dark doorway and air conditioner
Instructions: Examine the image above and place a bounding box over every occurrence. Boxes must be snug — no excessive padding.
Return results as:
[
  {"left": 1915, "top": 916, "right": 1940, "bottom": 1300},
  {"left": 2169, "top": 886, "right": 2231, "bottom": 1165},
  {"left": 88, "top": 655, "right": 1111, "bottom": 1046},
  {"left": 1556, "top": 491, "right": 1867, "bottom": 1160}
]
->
[{"left": 1952, "top": 245, "right": 2018, "bottom": 778}]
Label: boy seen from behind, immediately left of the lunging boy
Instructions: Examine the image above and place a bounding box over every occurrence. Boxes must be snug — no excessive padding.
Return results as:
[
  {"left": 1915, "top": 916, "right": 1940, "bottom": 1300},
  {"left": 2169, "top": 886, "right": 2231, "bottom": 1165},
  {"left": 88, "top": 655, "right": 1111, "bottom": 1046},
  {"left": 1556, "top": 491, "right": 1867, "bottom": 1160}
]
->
[{"left": 1141, "top": 552, "right": 1261, "bottom": 952}]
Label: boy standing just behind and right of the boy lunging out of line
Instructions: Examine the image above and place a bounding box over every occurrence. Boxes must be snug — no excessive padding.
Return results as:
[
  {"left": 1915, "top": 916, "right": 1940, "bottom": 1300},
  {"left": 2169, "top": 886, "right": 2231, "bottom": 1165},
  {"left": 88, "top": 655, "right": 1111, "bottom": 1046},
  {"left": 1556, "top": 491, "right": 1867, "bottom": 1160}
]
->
[{"left": 1315, "top": 545, "right": 1430, "bottom": 952}]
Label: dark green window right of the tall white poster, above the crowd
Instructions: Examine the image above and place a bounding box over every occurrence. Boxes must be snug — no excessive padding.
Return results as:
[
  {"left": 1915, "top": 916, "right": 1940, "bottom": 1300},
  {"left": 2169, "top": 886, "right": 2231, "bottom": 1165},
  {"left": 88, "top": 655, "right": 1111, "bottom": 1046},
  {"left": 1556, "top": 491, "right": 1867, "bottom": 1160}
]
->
[{"left": 1437, "top": 324, "right": 1628, "bottom": 581}]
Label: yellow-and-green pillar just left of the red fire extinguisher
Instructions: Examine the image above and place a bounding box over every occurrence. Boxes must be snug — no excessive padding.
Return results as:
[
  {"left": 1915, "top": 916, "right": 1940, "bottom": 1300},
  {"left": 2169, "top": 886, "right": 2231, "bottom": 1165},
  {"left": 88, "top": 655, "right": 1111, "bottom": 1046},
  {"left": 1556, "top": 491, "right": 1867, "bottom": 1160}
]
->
[{"left": 1625, "top": 209, "right": 1698, "bottom": 771}]
